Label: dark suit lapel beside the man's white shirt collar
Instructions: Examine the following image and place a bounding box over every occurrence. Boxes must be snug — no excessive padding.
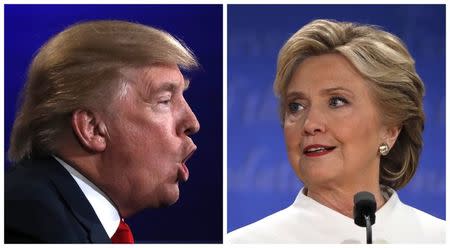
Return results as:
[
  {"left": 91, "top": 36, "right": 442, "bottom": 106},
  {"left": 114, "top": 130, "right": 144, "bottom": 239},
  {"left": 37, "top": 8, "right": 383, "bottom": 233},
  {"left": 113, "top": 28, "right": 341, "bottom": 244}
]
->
[{"left": 42, "top": 158, "right": 111, "bottom": 243}]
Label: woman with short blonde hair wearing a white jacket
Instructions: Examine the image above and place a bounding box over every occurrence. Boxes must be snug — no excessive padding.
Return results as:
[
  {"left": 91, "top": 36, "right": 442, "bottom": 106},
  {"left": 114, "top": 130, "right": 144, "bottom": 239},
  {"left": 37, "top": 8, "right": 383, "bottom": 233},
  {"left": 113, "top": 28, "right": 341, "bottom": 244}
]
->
[{"left": 228, "top": 20, "right": 445, "bottom": 243}]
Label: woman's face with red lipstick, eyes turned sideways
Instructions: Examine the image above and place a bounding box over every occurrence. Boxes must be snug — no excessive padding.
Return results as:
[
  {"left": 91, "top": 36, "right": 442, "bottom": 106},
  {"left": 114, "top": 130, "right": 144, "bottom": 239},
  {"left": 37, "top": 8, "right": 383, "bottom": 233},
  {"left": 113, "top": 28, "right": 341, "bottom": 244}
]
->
[{"left": 284, "top": 54, "right": 394, "bottom": 187}]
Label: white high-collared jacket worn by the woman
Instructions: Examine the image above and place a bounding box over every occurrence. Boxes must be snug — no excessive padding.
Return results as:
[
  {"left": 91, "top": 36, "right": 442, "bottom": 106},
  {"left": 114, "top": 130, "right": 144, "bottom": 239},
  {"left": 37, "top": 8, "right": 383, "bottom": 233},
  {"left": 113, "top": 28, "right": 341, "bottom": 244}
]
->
[{"left": 227, "top": 187, "right": 446, "bottom": 244}]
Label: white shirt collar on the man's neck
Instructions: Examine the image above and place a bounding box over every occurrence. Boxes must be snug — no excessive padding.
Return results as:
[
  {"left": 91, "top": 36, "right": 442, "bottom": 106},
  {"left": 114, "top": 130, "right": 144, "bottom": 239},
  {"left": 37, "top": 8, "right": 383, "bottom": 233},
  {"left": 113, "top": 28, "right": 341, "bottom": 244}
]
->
[{"left": 53, "top": 155, "right": 120, "bottom": 238}]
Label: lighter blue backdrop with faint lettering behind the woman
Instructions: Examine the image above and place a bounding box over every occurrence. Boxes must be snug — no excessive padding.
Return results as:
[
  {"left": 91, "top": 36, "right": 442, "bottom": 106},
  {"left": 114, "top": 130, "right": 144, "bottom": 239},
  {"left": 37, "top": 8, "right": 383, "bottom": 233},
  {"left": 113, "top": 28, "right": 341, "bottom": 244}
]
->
[{"left": 228, "top": 5, "right": 445, "bottom": 231}]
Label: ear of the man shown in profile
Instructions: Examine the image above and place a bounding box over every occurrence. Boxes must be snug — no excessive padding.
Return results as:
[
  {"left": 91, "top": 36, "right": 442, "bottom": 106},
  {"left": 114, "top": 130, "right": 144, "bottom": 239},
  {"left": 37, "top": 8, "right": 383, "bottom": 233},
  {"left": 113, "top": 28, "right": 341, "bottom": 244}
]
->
[{"left": 72, "top": 109, "right": 108, "bottom": 152}]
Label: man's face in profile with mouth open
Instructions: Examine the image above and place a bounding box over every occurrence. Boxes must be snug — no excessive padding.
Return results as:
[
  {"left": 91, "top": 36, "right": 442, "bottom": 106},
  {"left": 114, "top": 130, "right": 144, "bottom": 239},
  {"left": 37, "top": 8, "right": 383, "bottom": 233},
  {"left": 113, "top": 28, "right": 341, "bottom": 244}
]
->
[{"left": 102, "top": 65, "right": 199, "bottom": 215}]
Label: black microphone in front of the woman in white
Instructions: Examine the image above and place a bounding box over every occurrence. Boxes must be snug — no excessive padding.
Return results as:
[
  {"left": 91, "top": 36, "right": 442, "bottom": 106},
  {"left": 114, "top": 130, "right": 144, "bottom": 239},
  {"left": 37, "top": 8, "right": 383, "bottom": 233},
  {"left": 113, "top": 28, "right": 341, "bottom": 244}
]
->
[{"left": 353, "top": 191, "right": 377, "bottom": 244}]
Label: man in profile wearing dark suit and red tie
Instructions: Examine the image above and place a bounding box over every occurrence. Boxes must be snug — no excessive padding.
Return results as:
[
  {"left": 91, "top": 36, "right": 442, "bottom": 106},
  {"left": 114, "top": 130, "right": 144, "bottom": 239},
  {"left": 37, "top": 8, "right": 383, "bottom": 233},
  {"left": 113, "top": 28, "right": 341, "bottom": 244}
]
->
[{"left": 5, "top": 21, "right": 199, "bottom": 243}]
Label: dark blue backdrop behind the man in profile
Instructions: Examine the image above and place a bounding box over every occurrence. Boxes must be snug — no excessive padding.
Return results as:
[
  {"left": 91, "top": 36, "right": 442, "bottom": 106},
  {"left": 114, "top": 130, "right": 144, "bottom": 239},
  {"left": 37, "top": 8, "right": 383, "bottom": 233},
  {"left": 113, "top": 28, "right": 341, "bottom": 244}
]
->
[{"left": 4, "top": 5, "right": 223, "bottom": 243}]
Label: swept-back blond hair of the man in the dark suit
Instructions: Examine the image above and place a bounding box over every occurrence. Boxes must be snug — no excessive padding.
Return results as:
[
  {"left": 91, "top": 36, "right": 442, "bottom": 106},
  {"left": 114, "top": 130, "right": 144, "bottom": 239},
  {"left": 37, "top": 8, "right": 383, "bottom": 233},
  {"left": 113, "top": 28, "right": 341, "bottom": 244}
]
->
[{"left": 9, "top": 20, "right": 198, "bottom": 162}]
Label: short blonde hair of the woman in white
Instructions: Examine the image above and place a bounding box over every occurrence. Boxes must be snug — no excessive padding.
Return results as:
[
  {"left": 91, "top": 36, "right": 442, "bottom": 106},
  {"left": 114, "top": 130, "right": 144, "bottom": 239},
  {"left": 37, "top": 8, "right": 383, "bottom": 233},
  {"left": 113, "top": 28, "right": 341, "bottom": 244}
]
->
[{"left": 274, "top": 20, "right": 425, "bottom": 189}]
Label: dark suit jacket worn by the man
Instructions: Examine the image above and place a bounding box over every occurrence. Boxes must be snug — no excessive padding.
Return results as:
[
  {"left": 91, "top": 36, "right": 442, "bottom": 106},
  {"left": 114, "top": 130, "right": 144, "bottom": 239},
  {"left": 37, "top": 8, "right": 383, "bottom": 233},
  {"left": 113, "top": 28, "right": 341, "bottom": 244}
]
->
[{"left": 5, "top": 157, "right": 111, "bottom": 243}]
